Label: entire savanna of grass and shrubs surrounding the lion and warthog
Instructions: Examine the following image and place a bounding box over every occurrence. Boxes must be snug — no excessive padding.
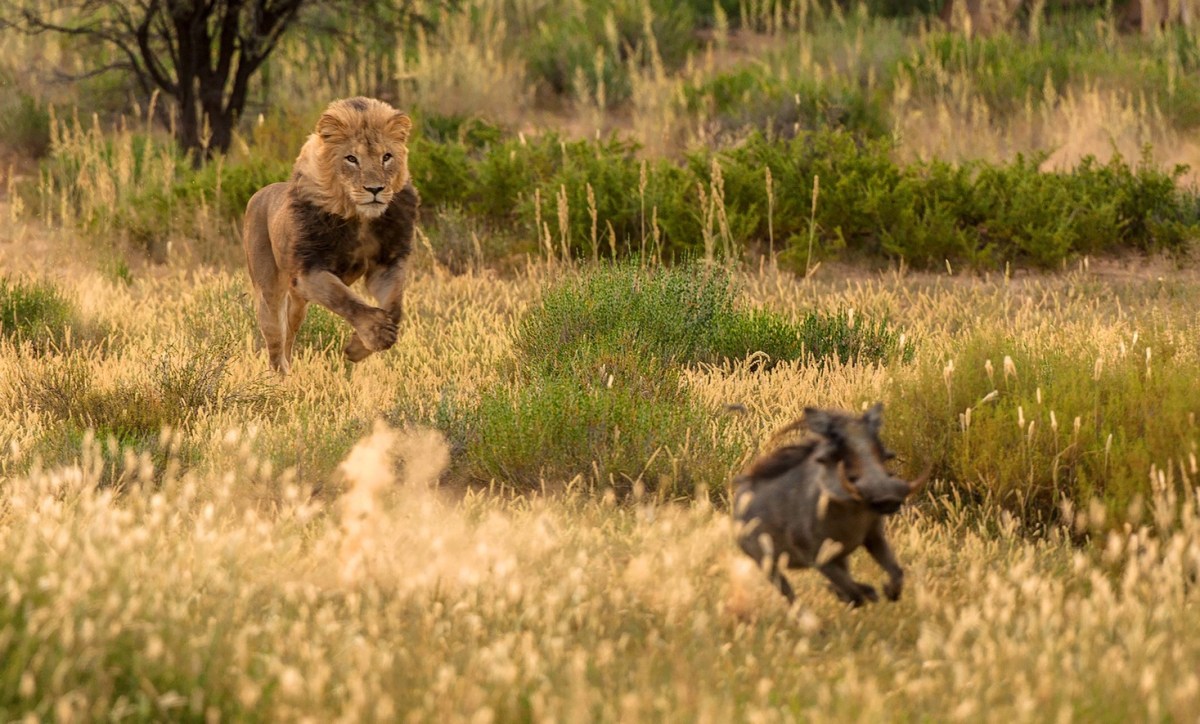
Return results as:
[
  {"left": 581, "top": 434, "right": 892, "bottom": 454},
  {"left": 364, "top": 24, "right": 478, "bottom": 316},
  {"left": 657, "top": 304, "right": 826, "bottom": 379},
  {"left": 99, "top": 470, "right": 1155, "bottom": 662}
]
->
[{"left": 0, "top": 0, "right": 1200, "bottom": 722}]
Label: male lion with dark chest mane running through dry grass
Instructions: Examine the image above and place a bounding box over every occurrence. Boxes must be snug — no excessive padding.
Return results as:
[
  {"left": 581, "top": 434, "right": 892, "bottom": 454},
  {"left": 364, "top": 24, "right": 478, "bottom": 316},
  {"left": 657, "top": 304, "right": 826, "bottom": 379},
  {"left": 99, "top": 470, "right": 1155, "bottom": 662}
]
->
[{"left": 242, "top": 97, "right": 420, "bottom": 375}]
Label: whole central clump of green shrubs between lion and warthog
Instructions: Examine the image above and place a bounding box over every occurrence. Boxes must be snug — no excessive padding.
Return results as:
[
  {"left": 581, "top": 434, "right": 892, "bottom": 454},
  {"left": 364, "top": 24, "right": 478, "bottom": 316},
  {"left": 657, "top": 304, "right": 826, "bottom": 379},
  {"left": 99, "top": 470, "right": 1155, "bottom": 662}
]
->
[{"left": 453, "top": 263, "right": 911, "bottom": 497}]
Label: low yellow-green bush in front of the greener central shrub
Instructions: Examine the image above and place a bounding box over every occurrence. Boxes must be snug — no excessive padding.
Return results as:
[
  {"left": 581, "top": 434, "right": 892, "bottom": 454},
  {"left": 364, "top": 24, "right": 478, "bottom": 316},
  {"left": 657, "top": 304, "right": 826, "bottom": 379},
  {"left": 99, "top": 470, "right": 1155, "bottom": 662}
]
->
[{"left": 466, "top": 354, "right": 724, "bottom": 498}]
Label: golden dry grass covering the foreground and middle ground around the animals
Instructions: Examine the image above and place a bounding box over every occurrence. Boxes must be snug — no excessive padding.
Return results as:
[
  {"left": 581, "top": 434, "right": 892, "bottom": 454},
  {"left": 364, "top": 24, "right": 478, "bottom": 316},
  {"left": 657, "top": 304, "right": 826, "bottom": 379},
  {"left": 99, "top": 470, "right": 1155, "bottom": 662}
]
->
[{"left": 0, "top": 228, "right": 1200, "bottom": 722}]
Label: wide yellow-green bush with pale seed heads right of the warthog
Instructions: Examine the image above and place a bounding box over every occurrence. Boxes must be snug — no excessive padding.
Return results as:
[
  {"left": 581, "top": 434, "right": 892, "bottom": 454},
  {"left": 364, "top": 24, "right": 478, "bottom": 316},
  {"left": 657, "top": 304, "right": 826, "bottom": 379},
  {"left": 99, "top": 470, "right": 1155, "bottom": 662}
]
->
[{"left": 888, "top": 334, "right": 1200, "bottom": 521}]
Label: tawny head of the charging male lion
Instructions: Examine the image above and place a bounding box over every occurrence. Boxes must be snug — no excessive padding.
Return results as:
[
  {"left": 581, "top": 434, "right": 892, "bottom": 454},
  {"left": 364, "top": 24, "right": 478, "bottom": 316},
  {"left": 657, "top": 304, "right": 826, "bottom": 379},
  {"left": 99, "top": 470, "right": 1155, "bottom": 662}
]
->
[{"left": 296, "top": 98, "right": 413, "bottom": 219}]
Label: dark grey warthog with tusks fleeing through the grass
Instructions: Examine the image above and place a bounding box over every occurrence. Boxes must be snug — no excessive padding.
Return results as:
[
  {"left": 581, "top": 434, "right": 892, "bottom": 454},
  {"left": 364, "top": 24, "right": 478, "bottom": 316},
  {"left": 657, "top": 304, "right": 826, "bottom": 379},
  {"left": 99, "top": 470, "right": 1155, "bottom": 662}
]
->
[{"left": 733, "top": 403, "right": 929, "bottom": 606}]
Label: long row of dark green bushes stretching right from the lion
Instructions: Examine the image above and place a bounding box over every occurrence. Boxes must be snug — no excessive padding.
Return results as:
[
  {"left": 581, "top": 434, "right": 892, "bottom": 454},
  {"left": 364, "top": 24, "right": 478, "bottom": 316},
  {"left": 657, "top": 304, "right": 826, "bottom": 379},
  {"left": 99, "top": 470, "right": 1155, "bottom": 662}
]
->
[{"left": 414, "top": 130, "right": 1200, "bottom": 269}]
